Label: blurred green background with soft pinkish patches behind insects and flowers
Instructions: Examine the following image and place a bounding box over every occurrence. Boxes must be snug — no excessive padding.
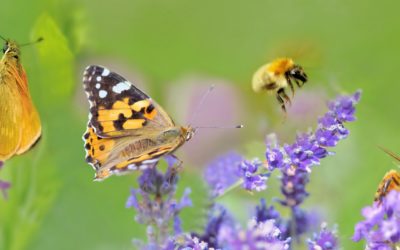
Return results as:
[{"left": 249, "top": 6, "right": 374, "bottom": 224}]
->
[{"left": 0, "top": 0, "right": 400, "bottom": 250}]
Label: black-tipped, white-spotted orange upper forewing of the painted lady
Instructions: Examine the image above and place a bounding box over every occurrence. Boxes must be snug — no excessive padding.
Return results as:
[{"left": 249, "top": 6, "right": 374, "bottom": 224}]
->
[{"left": 83, "top": 66, "right": 174, "bottom": 137}]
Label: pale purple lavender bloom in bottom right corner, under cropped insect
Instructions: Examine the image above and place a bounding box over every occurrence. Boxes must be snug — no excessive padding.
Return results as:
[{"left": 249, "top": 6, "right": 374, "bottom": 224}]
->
[{"left": 353, "top": 190, "right": 400, "bottom": 250}]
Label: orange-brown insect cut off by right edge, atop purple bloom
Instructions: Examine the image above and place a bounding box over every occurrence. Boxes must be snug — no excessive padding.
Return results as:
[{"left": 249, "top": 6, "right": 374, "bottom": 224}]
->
[{"left": 374, "top": 148, "right": 400, "bottom": 204}]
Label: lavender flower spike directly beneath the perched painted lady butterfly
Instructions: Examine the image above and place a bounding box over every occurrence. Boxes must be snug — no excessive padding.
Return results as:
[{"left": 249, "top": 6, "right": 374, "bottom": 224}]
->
[{"left": 126, "top": 164, "right": 192, "bottom": 250}]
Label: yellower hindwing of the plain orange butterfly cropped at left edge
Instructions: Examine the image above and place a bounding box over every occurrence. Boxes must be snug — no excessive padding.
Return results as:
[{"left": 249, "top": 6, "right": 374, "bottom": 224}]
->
[{"left": 0, "top": 75, "right": 22, "bottom": 161}]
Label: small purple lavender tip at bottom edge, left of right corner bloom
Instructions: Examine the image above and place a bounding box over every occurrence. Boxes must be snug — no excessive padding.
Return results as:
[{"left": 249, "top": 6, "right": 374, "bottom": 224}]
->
[{"left": 308, "top": 223, "right": 339, "bottom": 250}]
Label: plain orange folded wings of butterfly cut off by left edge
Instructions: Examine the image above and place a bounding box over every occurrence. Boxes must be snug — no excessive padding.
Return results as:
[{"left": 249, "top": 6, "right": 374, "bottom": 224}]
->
[{"left": 0, "top": 42, "right": 41, "bottom": 161}]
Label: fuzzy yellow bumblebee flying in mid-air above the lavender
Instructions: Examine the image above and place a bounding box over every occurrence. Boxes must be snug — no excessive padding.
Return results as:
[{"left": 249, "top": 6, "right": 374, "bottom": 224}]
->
[{"left": 252, "top": 58, "right": 307, "bottom": 113}]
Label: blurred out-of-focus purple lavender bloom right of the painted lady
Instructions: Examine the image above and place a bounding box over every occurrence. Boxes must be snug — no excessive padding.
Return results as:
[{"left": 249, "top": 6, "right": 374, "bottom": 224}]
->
[{"left": 204, "top": 152, "right": 243, "bottom": 197}]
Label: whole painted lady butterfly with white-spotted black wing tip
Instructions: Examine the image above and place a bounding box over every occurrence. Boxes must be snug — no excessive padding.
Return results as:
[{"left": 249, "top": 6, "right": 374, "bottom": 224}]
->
[{"left": 83, "top": 65, "right": 195, "bottom": 180}]
